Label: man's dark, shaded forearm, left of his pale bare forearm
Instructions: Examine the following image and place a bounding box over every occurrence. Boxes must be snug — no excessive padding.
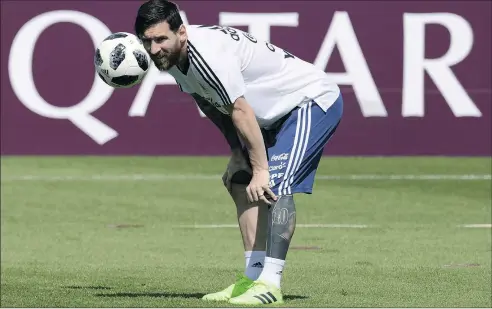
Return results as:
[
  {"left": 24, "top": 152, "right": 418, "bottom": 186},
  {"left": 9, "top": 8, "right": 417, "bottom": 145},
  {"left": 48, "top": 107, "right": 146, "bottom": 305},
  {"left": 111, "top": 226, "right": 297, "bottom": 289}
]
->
[{"left": 192, "top": 94, "right": 242, "bottom": 152}]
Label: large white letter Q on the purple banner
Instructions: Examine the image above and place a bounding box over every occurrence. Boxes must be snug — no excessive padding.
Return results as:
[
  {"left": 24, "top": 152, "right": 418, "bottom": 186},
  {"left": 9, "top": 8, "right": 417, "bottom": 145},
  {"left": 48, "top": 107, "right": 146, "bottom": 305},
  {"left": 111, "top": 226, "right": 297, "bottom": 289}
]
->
[{"left": 9, "top": 10, "right": 118, "bottom": 145}]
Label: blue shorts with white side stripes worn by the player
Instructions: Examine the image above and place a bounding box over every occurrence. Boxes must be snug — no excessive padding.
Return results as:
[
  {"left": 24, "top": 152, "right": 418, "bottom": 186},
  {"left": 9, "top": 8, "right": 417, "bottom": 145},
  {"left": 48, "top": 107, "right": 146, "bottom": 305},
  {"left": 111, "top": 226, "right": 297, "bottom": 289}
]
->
[{"left": 263, "top": 94, "right": 343, "bottom": 195}]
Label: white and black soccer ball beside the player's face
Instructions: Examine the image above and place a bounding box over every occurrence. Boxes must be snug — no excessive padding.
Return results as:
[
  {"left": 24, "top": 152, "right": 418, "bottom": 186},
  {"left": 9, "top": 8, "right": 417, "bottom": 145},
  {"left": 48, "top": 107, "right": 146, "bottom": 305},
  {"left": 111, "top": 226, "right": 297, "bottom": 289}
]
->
[{"left": 94, "top": 32, "right": 150, "bottom": 88}]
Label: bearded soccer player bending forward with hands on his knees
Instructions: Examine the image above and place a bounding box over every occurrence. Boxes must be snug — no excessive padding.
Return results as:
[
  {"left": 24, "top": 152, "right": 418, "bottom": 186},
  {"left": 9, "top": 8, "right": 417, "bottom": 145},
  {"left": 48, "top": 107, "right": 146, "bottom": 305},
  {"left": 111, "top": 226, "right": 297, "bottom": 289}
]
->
[{"left": 135, "top": 0, "right": 343, "bottom": 305}]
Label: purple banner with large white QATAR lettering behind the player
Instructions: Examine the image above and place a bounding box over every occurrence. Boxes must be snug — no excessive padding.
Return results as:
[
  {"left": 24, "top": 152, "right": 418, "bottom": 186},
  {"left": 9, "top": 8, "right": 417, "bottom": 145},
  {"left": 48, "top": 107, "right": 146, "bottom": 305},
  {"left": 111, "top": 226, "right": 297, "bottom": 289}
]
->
[{"left": 1, "top": 0, "right": 491, "bottom": 156}]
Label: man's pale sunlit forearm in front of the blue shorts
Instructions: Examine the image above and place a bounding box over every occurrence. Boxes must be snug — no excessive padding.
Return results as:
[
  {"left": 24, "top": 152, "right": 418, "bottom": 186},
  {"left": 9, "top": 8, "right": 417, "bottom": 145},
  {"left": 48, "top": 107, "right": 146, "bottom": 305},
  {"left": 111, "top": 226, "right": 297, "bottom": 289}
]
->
[{"left": 231, "top": 98, "right": 268, "bottom": 173}]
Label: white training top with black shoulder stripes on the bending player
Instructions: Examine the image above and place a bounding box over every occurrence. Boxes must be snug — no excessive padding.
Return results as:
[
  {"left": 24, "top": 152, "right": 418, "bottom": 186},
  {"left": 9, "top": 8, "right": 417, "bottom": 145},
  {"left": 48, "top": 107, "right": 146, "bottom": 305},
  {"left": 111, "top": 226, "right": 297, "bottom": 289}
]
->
[{"left": 168, "top": 25, "right": 340, "bottom": 128}]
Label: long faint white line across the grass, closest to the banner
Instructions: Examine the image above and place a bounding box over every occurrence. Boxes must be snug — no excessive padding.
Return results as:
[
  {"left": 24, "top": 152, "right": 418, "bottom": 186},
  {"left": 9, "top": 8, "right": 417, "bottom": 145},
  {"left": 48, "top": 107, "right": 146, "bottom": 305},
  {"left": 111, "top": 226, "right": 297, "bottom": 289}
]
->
[{"left": 1, "top": 174, "right": 492, "bottom": 181}]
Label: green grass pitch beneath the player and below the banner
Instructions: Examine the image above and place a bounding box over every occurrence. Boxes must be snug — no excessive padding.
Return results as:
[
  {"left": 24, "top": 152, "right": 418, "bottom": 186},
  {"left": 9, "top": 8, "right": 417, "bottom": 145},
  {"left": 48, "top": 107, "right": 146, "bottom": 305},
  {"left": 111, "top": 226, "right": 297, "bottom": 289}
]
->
[{"left": 1, "top": 157, "right": 492, "bottom": 307}]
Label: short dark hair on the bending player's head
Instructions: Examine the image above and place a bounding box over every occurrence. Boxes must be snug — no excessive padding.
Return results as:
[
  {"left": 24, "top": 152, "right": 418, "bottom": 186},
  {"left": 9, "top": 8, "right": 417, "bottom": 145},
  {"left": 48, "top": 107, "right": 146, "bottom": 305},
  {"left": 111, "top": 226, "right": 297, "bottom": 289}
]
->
[{"left": 135, "top": 0, "right": 183, "bottom": 37}]
